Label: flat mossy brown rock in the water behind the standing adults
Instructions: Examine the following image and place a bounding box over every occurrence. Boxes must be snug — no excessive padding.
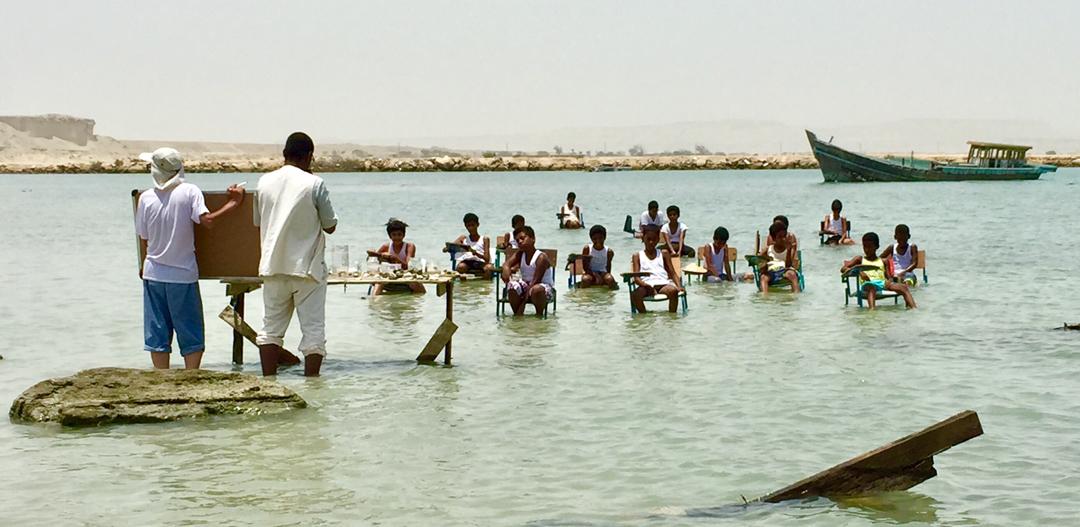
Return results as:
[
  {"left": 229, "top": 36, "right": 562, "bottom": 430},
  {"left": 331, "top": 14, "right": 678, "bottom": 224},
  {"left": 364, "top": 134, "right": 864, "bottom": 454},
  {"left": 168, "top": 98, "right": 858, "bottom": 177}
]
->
[{"left": 9, "top": 368, "right": 308, "bottom": 425}]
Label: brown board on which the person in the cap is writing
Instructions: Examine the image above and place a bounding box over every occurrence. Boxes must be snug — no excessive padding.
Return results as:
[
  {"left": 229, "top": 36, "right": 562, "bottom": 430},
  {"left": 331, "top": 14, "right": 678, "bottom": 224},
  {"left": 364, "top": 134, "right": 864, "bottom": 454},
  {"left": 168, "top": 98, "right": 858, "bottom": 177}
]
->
[{"left": 132, "top": 190, "right": 261, "bottom": 280}]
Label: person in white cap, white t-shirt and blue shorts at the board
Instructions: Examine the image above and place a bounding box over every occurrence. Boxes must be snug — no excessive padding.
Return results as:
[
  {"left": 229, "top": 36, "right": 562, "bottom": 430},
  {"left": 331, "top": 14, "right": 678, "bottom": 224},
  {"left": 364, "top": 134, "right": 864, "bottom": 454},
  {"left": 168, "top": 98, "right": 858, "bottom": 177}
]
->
[{"left": 135, "top": 148, "right": 244, "bottom": 369}]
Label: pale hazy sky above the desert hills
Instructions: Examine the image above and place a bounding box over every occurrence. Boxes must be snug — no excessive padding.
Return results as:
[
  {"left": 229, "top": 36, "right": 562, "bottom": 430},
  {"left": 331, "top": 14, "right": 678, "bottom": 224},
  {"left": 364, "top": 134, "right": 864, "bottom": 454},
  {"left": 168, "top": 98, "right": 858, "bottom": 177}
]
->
[{"left": 0, "top": 0, "right": 1080, "bottom": 141}]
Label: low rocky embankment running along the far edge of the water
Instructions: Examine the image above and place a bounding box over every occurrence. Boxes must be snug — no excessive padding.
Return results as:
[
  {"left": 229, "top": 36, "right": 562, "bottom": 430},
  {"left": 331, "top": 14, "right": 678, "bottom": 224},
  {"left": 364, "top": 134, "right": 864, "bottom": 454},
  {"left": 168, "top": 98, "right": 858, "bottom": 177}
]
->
[{"left": 0, "top": 152, "right": 1080, "bottom": 174}]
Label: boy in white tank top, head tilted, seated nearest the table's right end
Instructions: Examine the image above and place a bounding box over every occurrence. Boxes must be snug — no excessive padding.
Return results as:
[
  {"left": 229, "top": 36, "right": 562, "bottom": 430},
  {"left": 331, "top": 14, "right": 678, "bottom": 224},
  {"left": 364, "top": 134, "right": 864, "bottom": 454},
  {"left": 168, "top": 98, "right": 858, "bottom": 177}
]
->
[{"left": 502, "top": 225, "right": 555, "bottom": 316}]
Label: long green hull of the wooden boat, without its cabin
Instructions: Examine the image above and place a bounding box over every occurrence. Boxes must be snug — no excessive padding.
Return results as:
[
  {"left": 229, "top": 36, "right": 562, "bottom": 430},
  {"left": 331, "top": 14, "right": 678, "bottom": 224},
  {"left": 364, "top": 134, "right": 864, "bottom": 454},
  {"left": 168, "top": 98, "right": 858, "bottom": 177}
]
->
[{"left": 807, "top": 131, "right": 1055, "bottom": 183}]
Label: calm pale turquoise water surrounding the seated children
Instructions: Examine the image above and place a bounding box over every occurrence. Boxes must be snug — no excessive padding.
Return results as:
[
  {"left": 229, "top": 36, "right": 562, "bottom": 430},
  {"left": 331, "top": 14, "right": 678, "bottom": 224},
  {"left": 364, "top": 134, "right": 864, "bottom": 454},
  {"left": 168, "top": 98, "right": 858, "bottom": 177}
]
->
[{"left": 0, "top": 170, "right": 1080, "bottom": 526}]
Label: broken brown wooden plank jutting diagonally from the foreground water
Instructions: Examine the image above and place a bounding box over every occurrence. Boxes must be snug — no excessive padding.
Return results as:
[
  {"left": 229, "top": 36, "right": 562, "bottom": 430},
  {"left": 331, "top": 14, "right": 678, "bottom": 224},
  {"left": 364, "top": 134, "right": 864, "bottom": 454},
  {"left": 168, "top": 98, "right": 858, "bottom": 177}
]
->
[{"left": 758, "top": 410, "right": 983, "bottom": 503}]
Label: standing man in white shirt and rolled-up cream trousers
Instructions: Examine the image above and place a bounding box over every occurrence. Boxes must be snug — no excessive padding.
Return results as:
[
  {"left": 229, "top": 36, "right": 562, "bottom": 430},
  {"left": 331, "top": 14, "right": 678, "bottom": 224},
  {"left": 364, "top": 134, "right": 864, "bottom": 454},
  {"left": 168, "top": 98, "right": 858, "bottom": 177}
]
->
[{"left": 255, "top": 132, "right": 337, "bottom": 377}]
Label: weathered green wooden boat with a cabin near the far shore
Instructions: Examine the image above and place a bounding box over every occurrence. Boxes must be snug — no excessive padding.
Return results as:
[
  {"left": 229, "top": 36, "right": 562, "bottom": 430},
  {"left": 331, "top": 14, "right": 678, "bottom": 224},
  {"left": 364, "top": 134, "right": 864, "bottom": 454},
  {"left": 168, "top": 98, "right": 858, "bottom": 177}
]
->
[{"left": 807, "top": 130, "right": 1057, "bottom": 183}]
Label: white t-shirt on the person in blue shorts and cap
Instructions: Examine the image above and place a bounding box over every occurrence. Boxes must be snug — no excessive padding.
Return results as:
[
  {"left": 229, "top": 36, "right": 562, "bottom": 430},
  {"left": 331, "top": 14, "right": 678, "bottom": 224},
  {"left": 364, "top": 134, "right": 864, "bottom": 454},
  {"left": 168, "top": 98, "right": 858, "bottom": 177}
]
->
[{"left": 135, "top": 183, "right": 210, "bottom": 284}]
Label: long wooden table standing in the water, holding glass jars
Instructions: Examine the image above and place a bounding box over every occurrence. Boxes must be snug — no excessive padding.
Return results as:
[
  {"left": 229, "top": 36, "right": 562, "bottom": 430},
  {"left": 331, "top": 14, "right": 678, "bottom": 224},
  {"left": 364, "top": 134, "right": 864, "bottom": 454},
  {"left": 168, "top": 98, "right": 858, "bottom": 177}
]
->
[{"left": 220, "top": 274, "right": 457, "bottom": 366}]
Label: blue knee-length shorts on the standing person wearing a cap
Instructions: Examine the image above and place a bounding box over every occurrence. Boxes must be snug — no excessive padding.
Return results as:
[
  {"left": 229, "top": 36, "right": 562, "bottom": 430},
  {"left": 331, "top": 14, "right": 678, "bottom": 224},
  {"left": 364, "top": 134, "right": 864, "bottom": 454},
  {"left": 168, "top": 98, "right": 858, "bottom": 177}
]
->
[{"left": 143, "top": 280, "right": 206, "bottom": 355}]
